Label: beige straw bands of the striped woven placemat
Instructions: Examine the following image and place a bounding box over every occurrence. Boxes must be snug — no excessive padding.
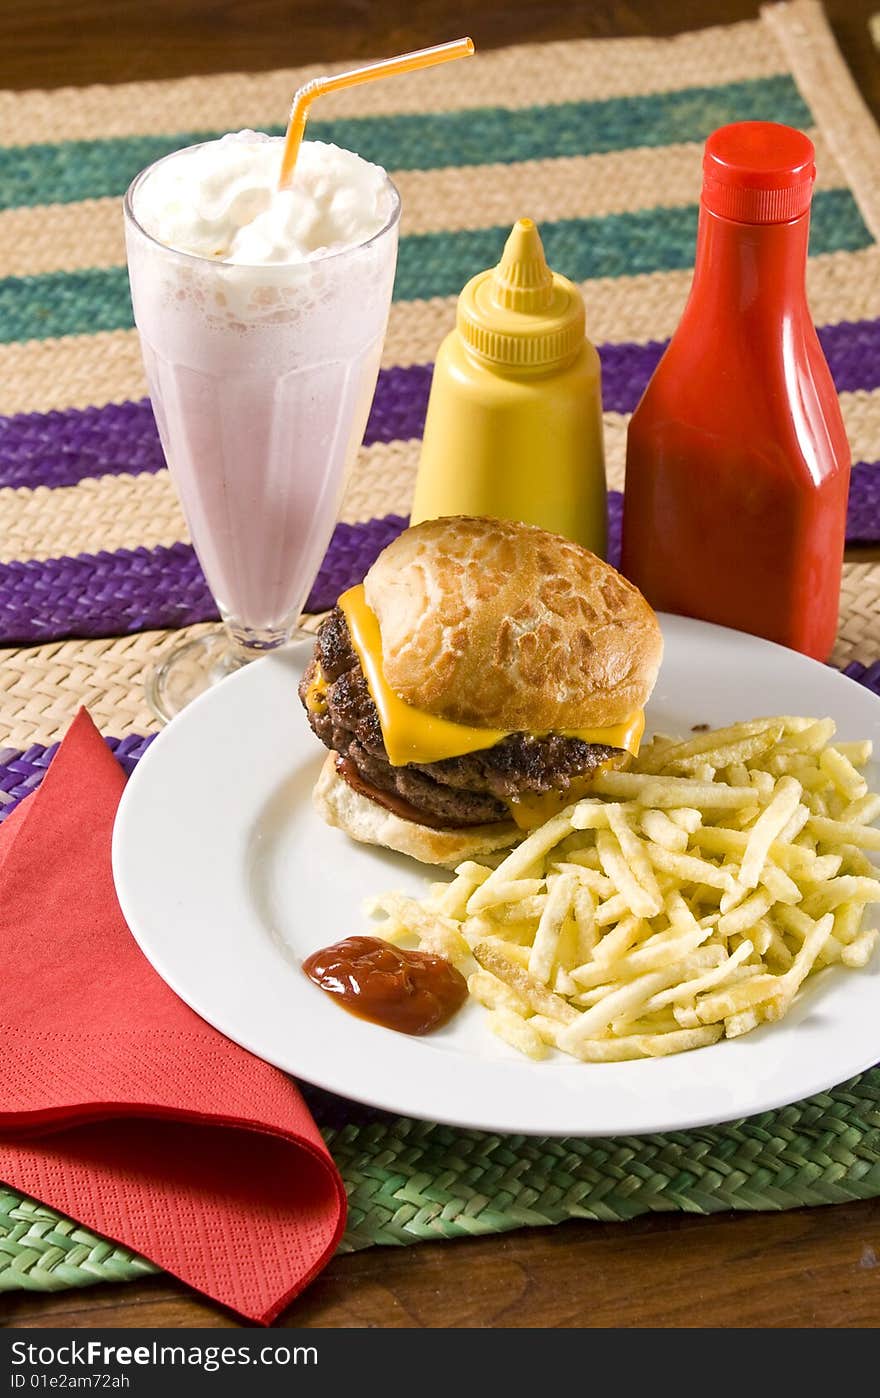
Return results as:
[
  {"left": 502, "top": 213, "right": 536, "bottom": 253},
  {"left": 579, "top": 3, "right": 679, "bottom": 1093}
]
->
[{"left": 0, "top": 0, "right": 880, "bottom": 748}]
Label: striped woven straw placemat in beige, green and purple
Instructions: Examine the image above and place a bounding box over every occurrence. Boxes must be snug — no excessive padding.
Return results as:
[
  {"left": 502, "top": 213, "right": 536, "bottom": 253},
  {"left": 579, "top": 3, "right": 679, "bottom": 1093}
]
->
[{"left": 0, "top": 0, "right": 880, "bottom": 1290}]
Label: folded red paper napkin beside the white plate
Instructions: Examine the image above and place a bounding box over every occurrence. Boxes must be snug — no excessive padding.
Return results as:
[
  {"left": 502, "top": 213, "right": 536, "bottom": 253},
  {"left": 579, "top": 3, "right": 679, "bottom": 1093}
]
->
[{"left": 0, "top": 710, "right": 346, "bottom": 1324}]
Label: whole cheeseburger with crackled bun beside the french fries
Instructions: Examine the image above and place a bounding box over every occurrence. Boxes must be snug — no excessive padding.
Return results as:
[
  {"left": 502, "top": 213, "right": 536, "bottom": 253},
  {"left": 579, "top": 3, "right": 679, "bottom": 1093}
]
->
[{"left": 299, "top": 516, "right": 663, "bottom": 865}]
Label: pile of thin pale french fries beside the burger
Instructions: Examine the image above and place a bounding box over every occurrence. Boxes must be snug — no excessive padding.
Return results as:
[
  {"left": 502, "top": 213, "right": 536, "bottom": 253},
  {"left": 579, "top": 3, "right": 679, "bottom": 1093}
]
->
[{"left": 368, "top": 716, "right": 880, "bottom": 1062}]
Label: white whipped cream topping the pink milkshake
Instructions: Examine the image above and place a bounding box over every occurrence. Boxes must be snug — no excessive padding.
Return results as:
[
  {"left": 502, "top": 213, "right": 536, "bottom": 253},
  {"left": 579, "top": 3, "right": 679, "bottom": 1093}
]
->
[{"left": 134, "top": 131, "right": 393, "bottom": 267}]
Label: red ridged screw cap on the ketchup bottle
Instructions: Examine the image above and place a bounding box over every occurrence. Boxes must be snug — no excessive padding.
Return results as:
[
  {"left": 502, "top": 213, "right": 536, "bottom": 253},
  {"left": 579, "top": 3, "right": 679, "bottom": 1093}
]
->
[{"left": 702, "top": 122, "right": 816, "bottom": 224}]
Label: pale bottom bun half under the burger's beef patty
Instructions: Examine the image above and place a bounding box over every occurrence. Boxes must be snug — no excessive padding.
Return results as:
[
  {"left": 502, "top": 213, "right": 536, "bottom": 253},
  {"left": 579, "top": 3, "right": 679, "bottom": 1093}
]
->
[{"left": 313, "top": 752, "right": 525, "bottom": 868}]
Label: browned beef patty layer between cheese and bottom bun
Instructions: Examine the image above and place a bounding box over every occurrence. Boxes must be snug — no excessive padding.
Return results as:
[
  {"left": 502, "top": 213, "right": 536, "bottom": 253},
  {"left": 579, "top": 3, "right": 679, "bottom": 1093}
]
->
[{"left": 299, "top": 607, "right": 623, "bottom": 826}]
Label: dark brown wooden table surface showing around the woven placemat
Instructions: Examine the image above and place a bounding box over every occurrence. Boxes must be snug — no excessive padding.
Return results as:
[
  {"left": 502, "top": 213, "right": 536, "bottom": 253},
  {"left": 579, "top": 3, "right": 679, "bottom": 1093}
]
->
[{"left": 0, "top": 0, "right": 880, "bottom": 1328}]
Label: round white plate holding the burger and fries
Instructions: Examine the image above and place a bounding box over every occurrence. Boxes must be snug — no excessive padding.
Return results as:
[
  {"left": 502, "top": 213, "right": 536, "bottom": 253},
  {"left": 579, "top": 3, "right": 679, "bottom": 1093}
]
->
[{"left": 113, "top": 617, "right": 880, "bottom": 1135}]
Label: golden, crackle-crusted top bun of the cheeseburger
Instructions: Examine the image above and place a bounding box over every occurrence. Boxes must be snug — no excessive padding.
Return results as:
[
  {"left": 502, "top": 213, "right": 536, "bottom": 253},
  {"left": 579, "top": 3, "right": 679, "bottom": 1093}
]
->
[{"left": 364, "top": 516, "right": 663, "bottom": 733}]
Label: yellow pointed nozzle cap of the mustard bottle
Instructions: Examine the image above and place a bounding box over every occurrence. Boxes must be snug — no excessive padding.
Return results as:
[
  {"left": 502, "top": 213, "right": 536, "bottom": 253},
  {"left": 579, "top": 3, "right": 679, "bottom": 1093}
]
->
[{"left": 457, "top": 218, "right": 586, "bottom": 369}]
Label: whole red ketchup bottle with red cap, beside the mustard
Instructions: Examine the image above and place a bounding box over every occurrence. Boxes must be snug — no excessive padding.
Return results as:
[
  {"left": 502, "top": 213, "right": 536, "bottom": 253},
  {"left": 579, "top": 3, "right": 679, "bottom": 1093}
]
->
[{"left": 623, "top": 122, "right": 849, "bottom": 660}]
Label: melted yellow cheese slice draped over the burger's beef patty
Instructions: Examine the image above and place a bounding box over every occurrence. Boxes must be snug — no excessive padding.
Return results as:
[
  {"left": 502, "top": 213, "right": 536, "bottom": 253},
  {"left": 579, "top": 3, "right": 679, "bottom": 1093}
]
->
[{"left": 332, "top": 586, "right": 645, "bottom": 771}]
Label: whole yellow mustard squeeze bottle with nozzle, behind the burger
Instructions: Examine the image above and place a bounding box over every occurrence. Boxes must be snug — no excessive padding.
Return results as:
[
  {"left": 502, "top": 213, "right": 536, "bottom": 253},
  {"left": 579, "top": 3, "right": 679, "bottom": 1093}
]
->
[{"left": 411, "top": 218, "right": 607, "bottom": 556}]
